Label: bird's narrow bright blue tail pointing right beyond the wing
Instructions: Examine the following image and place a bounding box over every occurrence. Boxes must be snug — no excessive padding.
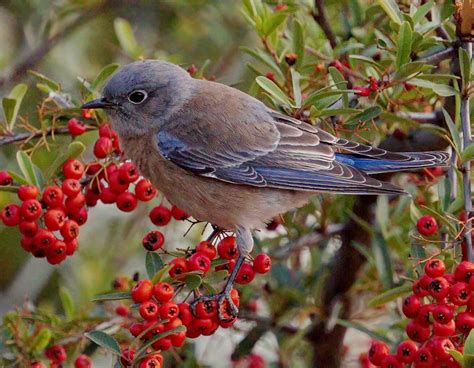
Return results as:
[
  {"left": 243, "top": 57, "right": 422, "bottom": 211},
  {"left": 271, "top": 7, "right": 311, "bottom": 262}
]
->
[{"left": 336, "top": 151, "right": 450, "bottom": 174}]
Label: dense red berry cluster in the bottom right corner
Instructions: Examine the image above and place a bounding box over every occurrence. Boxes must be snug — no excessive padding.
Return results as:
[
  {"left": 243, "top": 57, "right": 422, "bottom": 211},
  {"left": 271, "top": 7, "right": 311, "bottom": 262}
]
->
[{"left": 369, "top": 259, "right": 474, "bottom": 368}]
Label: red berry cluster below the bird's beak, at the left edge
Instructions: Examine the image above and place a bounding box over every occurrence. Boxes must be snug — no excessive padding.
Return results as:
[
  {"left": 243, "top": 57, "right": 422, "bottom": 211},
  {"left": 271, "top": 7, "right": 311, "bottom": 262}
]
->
[{"left": 0, "top": 119, "right": 159, "bottom": 264}]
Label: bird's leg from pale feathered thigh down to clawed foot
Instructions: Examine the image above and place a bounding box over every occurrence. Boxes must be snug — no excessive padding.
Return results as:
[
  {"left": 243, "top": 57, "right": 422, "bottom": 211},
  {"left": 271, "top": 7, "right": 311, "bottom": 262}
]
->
[{"left": 191, "top": 227, "right": 253, "bottom": 322}]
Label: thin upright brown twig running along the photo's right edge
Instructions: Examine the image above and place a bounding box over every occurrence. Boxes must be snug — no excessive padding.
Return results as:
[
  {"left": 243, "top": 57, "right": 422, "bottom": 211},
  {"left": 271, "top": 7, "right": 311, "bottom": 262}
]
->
[{"left": 461, "top": 42, "right": 473, "bottom": 262}]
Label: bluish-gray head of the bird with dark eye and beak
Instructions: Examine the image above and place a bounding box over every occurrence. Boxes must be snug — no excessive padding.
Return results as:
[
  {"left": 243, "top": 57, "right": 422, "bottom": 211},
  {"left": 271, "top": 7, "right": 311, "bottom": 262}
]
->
[{"left": 82, "top": 60, "right": 193, "bottom": 138}]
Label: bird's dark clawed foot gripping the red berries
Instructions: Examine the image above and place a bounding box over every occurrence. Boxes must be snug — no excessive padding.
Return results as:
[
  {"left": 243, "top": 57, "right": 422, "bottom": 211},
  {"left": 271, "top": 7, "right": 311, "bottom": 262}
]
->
[{"left": 190, "top": 290, "right": 239, "bottom": 322}]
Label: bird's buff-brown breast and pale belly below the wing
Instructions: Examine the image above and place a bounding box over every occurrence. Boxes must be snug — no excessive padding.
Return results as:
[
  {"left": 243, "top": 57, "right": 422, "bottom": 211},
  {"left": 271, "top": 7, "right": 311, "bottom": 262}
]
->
[{"left": 124, "top": 137, "right": 314, "bottom": 230}]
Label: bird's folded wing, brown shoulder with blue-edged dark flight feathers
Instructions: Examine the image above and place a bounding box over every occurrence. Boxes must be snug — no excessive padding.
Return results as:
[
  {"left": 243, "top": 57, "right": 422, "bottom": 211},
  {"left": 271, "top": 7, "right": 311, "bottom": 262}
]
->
[{"left": 156, "top": 82, "right": 432, "bottom": 194}]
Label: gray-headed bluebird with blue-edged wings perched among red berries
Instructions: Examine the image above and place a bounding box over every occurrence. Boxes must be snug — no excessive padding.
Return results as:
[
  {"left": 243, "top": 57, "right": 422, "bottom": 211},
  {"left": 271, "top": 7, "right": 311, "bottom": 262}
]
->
[{"left": 81, "top": 60, "right": 449, "bottom": 319}]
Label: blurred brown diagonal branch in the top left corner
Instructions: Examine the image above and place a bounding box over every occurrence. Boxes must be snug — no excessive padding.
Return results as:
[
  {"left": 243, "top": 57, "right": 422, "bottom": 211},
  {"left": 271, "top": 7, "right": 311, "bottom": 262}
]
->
[{"left": 0, "top": 0, "right": 111, "bottom": 88}]
